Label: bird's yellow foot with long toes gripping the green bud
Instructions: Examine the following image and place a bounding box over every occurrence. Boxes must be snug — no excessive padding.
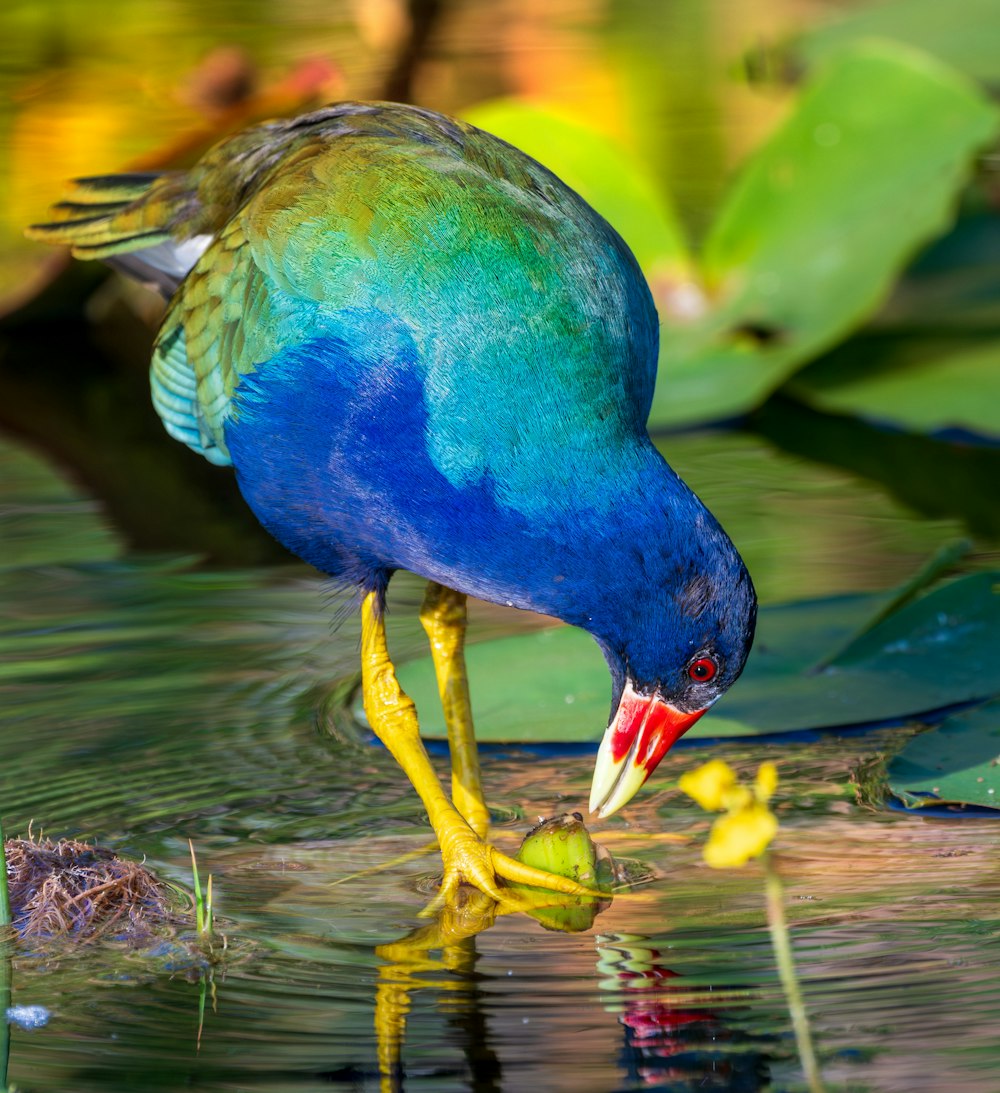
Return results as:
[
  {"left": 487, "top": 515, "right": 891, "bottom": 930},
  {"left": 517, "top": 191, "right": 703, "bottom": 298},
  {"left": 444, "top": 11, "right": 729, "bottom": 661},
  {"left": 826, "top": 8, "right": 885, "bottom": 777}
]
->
[{"left": 422, "top": 824, "right": 607, "bottom": 916}]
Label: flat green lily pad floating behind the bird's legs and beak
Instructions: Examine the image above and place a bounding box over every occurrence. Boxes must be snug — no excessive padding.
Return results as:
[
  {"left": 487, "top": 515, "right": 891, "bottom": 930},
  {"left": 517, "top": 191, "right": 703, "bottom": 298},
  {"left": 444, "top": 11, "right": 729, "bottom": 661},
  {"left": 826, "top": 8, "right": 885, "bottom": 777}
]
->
[{"left": 400, "top": 573, "right": 1000, "bottom": 742}]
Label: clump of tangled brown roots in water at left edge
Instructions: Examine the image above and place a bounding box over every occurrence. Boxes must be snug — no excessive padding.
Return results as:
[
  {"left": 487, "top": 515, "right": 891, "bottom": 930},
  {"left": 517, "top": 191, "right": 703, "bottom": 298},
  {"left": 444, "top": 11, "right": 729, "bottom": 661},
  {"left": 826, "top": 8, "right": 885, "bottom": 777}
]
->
[{"left": 4, "top": 838, "right": 169, "bottom": 940}]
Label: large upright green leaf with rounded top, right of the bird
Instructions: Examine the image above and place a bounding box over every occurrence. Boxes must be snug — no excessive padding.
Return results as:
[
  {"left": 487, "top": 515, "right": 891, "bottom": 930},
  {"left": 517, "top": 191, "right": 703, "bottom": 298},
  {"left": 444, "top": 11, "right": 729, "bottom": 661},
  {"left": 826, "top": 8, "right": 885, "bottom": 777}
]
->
[{"left": 651, "top": 43, "right": 998, "bottom": 425}]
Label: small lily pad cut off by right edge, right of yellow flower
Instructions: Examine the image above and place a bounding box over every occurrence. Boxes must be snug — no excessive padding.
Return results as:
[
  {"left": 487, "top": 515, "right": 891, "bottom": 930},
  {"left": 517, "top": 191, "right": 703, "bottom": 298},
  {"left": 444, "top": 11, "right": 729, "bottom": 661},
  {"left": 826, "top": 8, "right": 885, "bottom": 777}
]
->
[{"left": 886, "top": 702, "right": 1000, "bottom": 809}]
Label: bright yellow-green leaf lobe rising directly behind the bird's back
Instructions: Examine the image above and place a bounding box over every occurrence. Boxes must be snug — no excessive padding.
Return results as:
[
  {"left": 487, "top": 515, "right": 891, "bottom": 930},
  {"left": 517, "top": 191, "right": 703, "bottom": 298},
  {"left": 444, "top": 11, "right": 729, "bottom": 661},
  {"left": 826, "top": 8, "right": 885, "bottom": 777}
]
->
[{"left": 463, "top": 98, "right": 689, "bottom": 279}]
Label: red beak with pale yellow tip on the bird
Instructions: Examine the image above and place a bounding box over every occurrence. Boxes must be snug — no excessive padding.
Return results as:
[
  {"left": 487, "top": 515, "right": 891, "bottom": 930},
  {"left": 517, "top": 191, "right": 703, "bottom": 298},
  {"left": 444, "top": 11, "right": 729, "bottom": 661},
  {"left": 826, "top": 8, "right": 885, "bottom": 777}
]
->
[{"left": 590, "top": 683, "right": 705, "bottom": 816}]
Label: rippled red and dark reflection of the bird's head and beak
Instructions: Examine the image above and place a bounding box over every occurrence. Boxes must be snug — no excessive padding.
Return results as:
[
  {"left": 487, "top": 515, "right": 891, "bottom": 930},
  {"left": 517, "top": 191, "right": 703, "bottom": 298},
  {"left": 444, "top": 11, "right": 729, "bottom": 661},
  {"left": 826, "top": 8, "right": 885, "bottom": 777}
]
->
[{"left": 598, "top": 933, "right": 770, "bottom": 1093}]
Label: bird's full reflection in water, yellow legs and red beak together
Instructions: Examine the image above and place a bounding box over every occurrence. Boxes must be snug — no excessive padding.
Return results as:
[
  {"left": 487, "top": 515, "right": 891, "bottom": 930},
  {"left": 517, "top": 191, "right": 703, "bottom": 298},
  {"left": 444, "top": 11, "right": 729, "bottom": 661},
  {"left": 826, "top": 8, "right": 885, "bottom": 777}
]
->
[{"left": 375, "top": 888, "right": 770, "bottom": 1093}]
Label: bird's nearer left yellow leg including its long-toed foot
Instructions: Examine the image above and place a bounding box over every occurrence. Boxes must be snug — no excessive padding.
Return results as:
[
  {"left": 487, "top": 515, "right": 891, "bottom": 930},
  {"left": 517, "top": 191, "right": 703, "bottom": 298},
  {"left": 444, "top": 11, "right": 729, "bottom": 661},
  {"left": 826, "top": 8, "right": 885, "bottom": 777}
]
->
[{"left": 361, "top": 592, "right": 592, "bottom": 902}]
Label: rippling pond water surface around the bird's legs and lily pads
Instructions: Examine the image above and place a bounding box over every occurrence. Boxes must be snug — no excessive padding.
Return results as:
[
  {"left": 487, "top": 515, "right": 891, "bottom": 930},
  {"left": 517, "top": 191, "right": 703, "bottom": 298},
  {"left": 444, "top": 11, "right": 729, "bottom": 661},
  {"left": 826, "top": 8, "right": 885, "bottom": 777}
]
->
[{"left": 0, "top": 434, "right": 1000, "bottom": 1093}]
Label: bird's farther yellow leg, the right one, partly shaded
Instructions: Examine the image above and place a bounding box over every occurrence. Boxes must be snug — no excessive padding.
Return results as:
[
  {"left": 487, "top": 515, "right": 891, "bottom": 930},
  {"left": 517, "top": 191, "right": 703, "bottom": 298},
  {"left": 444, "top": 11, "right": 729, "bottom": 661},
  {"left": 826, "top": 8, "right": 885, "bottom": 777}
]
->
[{"left": 420, "top": 580, "right": 490, "bottom": 838}]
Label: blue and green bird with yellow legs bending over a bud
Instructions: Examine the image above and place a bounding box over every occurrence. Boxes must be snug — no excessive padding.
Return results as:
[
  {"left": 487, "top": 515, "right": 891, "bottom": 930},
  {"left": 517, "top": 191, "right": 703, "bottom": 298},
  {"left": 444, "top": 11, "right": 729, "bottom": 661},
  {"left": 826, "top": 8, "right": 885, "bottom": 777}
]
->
[{"left": 30, "top": 103, "right": 756, "bottom": 898}]
